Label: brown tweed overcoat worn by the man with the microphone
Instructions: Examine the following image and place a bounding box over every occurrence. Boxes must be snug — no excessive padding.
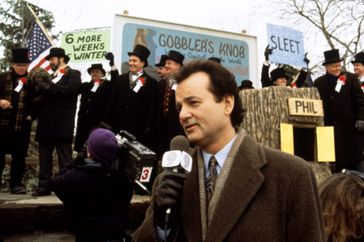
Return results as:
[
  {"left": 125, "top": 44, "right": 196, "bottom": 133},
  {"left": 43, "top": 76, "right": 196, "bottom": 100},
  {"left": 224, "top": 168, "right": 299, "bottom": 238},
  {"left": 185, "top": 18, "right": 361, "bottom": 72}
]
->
[{"left": 133, "top": 130, "right": 324, "bottom": 242}]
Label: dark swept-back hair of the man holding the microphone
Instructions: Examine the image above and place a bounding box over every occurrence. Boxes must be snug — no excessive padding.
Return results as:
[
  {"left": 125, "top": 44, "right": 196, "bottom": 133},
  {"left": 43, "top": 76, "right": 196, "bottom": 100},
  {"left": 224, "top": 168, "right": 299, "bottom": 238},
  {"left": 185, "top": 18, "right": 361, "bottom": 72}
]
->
[{"left": 176, "top": 60, "right": 245, "bottom": 130}]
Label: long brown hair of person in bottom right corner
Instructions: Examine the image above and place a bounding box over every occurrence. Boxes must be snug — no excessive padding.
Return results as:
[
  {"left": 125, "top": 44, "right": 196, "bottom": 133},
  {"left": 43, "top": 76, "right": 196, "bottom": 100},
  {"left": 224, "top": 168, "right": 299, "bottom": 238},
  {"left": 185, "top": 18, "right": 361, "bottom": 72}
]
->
[{"left": 319, "top": 173, "right": 364, "bottom": 242}]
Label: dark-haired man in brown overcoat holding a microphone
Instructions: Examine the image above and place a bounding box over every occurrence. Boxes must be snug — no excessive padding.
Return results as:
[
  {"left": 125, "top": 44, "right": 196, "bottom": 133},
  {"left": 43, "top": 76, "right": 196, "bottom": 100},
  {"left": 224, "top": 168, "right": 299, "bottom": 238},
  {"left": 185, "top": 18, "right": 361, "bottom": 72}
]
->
[{"left": 133, "top": 61, "right": 325, "bottom": 242}]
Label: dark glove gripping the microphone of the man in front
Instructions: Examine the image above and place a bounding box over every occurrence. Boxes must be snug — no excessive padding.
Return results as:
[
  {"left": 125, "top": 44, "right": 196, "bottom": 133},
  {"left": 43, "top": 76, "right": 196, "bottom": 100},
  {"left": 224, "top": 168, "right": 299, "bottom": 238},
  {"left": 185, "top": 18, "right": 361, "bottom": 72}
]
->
[{"left": 153, "top": 171, "right": 187, "bottom": 229}]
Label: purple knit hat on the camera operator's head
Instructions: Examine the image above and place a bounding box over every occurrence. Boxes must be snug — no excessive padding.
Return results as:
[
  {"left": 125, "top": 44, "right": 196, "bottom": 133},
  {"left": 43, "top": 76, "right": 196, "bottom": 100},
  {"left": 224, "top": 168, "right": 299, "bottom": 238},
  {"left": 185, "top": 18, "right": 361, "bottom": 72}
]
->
[{"left": 86, "top": 128, "right": 118, "bottom": 162}]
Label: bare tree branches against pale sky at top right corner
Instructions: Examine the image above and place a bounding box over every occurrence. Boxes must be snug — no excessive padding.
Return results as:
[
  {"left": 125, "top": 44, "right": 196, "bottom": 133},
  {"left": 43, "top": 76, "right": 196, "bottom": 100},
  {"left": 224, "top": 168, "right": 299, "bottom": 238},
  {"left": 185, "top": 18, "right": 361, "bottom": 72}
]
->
[{"left": 280, "top": 0, "right": 364, "bottom": 70}]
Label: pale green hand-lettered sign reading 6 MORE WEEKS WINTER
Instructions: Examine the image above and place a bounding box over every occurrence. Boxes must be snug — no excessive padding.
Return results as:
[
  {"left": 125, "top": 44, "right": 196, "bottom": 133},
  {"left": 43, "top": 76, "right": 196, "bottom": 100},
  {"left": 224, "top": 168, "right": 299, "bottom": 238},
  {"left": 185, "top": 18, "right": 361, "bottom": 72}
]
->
[{"left": 61, "top": 29, "right": 110, "bottom": 62}]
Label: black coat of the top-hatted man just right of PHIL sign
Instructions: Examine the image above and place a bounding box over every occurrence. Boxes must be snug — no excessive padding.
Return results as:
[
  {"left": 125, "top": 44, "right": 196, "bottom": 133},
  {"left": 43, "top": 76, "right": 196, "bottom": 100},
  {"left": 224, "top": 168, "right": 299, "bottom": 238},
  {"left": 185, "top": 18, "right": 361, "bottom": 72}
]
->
[{"left": 314, "top": 73, "right": 364, "bottom": 169}]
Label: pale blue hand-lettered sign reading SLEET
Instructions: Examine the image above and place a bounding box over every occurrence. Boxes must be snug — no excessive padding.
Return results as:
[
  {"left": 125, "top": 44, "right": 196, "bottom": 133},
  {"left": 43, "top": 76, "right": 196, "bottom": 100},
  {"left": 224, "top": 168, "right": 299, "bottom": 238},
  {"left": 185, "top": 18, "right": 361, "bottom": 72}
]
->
[{"left": 267, "top": 24, "right": 306, "bottom": 67}]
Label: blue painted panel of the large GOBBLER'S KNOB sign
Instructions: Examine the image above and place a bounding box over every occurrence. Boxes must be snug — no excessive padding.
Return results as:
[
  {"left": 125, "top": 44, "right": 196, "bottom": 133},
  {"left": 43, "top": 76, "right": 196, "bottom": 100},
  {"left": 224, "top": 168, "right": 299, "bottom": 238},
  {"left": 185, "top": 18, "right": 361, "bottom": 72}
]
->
[{"left": 120, "top": 23, "right": 249, "bottom": 82}]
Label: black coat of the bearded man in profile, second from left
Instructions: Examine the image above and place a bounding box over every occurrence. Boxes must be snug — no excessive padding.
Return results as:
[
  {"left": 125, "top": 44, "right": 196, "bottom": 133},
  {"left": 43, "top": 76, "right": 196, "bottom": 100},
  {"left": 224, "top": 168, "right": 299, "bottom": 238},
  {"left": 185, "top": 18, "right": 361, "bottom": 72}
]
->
[{"left": 36, "top": 67, "right": 81, "bottom": 142}]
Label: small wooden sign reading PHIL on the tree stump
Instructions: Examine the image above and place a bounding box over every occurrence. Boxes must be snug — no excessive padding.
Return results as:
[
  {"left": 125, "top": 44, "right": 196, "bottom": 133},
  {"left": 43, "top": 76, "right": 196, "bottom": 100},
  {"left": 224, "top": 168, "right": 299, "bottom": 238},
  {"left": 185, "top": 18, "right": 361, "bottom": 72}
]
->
[{"left": 288, "top": 98, "right": 324, "bottom": 117}]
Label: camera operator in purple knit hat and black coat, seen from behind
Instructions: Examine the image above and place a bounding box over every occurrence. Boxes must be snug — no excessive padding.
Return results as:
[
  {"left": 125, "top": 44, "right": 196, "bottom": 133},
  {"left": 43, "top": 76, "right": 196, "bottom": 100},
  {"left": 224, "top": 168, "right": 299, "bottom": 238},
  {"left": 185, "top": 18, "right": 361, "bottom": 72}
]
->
[{"left": 50, "top": 128, "right": 133, "bottom": 241}]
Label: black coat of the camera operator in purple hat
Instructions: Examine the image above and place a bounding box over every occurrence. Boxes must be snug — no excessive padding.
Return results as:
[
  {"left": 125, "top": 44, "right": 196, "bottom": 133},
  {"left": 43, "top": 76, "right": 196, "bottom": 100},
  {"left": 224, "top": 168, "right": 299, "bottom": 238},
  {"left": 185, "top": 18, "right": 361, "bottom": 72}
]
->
[{"left": 50, "top": 158, "right": 133, "bottom": 241}]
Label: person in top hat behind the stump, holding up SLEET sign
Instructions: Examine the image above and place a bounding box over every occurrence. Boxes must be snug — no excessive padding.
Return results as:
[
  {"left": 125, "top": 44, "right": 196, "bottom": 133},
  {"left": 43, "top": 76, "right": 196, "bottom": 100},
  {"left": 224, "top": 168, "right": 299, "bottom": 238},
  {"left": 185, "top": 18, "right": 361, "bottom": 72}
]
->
[{"left": 261, "top": 46, "right": 308, "bottom": 87}]
